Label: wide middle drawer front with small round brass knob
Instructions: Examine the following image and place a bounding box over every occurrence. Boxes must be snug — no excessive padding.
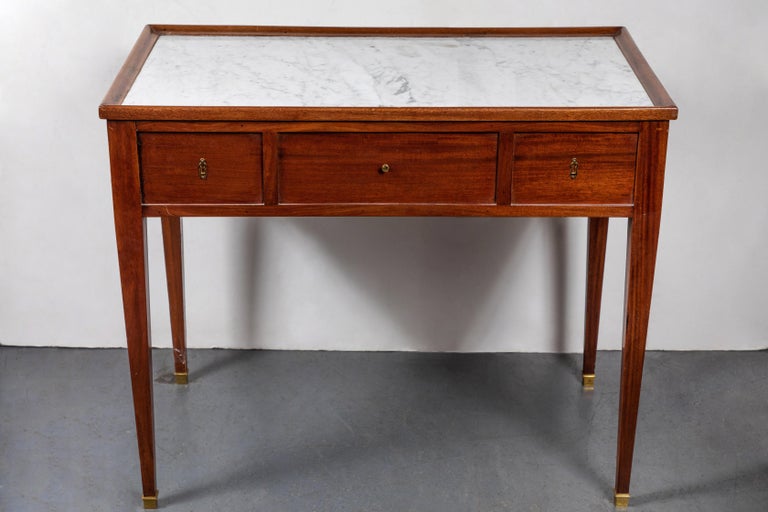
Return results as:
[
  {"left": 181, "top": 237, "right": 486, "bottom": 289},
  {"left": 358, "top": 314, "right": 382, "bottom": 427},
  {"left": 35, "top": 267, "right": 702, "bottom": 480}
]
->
[{"left": 279, "top": 133, "right": 498, "bottom": 204}]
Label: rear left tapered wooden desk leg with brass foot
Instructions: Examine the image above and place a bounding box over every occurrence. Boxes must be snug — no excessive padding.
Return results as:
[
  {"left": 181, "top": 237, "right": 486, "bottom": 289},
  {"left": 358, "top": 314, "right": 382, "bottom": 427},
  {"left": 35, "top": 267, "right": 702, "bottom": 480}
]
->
[{"left": 160, "top": 217, "right": 189, "bottom": 384}]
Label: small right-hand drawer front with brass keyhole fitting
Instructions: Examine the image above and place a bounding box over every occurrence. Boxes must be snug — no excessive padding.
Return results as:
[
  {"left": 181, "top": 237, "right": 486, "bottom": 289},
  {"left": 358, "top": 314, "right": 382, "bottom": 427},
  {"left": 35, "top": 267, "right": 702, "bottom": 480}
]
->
[{"left": 512, "top": 133, "right": 637, "bottom": 204}]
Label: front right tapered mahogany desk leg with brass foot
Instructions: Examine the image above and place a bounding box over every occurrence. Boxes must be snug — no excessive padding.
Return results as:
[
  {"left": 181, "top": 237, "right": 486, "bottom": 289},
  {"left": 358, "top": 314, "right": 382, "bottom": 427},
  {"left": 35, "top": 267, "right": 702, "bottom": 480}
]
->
[{"left": 614, "top": 122, "right": 668, "bottom": 507}]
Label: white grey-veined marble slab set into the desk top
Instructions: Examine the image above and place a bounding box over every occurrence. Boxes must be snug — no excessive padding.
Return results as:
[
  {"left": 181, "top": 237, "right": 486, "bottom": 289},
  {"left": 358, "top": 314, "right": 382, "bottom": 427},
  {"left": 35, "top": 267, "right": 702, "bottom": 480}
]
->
[{"left": 123, "top": 35, "right": 652, "bottom": 107}]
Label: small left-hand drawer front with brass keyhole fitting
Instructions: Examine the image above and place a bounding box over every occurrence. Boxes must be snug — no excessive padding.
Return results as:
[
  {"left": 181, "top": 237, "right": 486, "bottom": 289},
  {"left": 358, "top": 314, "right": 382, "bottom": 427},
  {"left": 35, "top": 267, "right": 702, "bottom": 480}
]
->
[{"left": 139, "top": 133, "right": 262, "bottom": 204}]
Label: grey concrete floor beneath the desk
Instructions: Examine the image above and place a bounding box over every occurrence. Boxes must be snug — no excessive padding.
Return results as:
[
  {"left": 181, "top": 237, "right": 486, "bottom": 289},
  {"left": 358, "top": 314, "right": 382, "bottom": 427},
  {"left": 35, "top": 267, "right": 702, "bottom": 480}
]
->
[{"left": 0, "top": 347, "right": 768, "bottom": 512}]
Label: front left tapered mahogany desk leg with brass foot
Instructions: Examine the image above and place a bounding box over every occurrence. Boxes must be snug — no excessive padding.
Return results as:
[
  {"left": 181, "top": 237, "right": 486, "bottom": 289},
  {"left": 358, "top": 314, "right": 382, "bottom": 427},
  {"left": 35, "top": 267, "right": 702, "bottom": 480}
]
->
[{"left": 107, "top": 121, "right": 157, "bottom": 508}]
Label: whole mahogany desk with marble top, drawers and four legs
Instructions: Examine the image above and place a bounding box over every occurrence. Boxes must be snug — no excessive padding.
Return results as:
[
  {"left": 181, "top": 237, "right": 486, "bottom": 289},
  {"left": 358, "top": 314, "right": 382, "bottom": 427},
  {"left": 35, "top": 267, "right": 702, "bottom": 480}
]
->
[{"left": 99, "top": 26, "right": 677, "bottom": 508}]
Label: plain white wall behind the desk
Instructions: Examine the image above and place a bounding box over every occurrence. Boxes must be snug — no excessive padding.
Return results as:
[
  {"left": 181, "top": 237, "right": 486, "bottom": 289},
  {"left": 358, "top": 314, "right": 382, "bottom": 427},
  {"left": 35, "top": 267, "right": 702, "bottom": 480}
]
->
[{"left": 0, "top": 0, "right": 768, "bottom": 351}]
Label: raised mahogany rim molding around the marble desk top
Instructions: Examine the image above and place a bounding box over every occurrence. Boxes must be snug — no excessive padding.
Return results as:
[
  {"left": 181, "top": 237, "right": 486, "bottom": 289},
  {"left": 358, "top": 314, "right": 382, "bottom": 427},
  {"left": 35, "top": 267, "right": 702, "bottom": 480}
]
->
[{"left": 99, "top": 25, "right": 677, "bottom": 122}]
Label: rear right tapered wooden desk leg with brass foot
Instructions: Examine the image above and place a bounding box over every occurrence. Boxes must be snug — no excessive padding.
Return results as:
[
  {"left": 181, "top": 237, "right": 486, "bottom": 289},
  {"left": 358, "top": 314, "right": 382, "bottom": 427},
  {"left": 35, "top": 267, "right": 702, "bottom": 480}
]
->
[{"left": 581, "top": 217, "right": 608, "bottom": 390}]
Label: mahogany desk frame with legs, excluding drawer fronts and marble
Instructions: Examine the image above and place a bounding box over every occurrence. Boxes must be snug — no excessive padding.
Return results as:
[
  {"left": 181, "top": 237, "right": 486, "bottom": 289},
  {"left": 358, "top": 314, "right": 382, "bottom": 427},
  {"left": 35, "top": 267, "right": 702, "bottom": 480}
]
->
[{"left": 99, "top": 25, "right": 677, "bottom": 508}]
